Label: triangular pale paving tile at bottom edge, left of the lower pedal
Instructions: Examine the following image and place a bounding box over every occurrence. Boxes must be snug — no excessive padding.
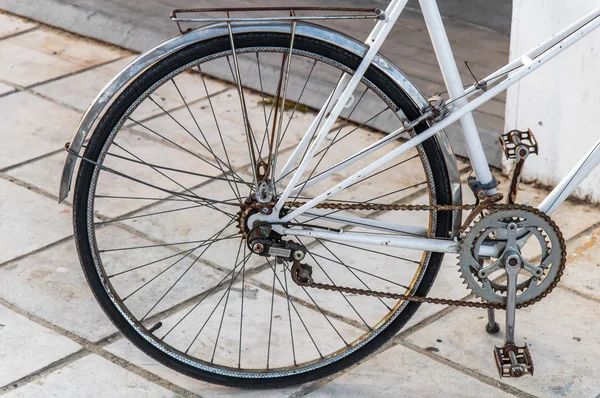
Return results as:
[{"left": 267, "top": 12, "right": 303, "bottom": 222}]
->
[{"left": 308, "top": 346, "right": 511, "bottom": 398}]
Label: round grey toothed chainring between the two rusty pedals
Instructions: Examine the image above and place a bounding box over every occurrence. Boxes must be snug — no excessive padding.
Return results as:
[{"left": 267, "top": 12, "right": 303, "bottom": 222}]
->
[{"left": 459, "top": 205, "right": 566, "bottom": 305}]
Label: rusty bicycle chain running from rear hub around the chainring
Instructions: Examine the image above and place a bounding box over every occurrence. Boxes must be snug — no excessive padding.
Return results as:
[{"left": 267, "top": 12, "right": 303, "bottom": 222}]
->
[{"left": 285, "top": 202, "right": 567, "bottom": 309}]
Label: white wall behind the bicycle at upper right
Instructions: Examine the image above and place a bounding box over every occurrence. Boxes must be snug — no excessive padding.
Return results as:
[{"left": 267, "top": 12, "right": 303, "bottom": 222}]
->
[{"left": 505, "top": 0, "right": 600, "bottom": 202}]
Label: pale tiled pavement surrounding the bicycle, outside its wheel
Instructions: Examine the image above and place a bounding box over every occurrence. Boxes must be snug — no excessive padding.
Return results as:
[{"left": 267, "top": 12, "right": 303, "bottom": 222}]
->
[{"left": 0, "top": 14, "right": 600, "bottom": 397}]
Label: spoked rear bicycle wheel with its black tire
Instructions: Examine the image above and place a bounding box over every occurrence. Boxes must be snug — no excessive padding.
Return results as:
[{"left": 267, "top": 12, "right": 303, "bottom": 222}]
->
[{"left": 74, "top": 33, "right": 451, "bottom": 388}]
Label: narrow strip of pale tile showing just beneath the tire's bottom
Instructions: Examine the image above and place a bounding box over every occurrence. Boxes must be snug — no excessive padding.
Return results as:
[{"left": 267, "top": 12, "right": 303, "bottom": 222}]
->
[{"left": 105, "top": 339, "right": 301, "bottom": 398}]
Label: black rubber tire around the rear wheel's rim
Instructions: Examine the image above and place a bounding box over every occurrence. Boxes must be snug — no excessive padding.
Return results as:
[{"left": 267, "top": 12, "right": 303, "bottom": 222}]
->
[{"left": 73, "top": 33, "right": 452, "bottom": 388}]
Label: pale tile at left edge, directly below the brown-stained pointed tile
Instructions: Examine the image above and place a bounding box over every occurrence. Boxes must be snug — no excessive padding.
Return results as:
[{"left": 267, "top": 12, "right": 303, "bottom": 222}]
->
[{"left": 0, "top": 92, "right": 81, "bottom": 169}]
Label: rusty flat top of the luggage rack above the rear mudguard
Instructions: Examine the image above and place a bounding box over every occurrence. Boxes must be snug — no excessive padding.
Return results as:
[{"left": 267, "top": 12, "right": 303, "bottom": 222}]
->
[{"left": 171, "top": 7, "right": 385, "bottom": 33}]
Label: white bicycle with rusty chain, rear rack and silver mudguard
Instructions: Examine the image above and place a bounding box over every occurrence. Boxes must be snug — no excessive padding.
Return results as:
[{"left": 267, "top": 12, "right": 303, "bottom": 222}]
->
[{"left": 59, "top": 0, "right": 600, "bottom": 388}]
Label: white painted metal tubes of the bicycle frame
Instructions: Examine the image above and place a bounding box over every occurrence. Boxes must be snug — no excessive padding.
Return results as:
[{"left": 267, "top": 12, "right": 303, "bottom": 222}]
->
[{"left": 264, "top": 0, "right": 600, "bottom": 255}]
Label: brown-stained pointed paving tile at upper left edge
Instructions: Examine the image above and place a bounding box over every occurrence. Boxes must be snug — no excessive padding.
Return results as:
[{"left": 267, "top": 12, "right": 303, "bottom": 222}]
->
[{"left": 0, "top": 28, "right": 127, "bottom": 86}]
